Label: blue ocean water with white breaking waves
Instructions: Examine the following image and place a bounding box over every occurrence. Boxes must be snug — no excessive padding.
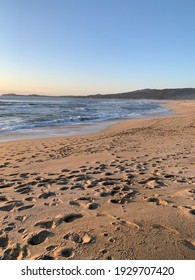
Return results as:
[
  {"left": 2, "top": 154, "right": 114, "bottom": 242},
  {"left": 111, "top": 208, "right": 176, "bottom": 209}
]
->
[{"left": 0, "top": 96, "right": 169, "bottom": 138}]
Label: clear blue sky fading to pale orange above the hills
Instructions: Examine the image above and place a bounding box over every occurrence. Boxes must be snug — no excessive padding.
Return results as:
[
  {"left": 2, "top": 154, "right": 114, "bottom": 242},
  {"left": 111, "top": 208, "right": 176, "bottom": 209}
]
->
[{"left": 0, "top": 0, "right": 195, "bottom": 95}]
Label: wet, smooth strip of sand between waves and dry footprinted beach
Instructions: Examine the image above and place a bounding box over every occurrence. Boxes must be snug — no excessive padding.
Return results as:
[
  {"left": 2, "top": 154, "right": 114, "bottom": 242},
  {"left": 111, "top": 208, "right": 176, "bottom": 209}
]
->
[{"left": 0, "top": 100, "right": 184, "bottom": 143}]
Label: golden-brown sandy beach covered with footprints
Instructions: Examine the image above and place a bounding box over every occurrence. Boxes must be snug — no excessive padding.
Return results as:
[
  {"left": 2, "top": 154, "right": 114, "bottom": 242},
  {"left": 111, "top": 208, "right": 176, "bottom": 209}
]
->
[{"left": 0, "top": 101, "right": 195, "bottom": 260}]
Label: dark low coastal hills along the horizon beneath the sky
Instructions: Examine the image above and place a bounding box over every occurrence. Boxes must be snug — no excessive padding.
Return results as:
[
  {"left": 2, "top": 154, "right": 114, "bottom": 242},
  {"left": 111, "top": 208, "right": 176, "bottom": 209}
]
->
[{"left": 2, "top": 88, "right": 195, "bottom": 100}]
